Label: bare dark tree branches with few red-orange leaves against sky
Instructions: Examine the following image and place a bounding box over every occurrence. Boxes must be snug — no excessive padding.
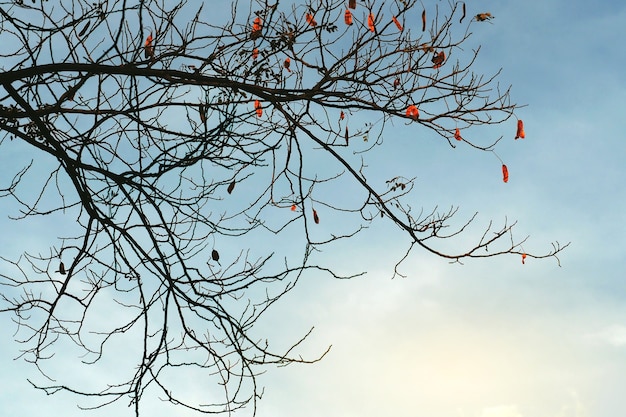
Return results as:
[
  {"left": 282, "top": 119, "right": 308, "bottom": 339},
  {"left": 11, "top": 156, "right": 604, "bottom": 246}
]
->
[{"left": 0, "top": 0, "right": 567, "bottom": 415}]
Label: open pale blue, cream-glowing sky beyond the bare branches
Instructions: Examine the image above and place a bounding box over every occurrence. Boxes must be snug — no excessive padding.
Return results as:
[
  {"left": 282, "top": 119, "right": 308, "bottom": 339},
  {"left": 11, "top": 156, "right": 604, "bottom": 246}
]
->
[{"left": 0, "top": 0, "right": 626, "bottom": 417}]
